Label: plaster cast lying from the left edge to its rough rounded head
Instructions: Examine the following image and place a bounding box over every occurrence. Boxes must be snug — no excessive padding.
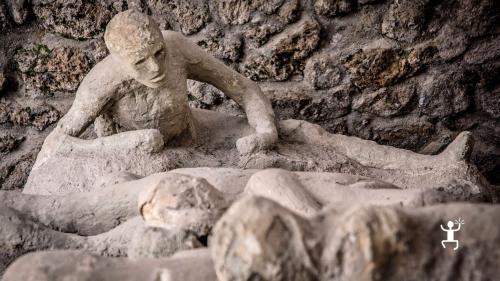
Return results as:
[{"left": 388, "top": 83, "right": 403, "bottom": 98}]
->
[{"left": 0, "top": 172, "right": 233, "bottom": 236}]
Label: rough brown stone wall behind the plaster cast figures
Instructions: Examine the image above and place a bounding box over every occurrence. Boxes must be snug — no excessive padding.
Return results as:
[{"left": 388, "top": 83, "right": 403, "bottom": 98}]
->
[{"left": 0, "top": 0, "right": 500, "bottom": 189}]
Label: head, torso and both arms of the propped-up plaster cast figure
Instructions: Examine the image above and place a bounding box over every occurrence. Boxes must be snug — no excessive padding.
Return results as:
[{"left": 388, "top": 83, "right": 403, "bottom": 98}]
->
[{"left": 42, "top": 10, "right": 278, "bottom": 162}]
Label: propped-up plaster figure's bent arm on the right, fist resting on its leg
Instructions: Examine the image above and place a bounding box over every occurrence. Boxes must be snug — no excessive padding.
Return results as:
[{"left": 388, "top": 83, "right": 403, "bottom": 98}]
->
[{"left": 171, "top": 32, "right": 278, "bottom": 154}]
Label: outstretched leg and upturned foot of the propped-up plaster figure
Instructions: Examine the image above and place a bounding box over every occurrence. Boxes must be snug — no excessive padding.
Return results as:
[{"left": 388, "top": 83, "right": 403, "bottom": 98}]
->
[{"left": 278, "top": 120, "right": 484, "bottom": 190}]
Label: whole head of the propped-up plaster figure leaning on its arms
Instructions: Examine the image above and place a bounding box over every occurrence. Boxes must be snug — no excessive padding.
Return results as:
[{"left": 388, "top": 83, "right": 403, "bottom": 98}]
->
[{"left": 104, "top": 10, "right": 166, "bottom": 88}]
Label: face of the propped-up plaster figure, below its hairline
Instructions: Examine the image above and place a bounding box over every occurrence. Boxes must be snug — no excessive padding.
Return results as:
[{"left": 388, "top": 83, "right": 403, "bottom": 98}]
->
[{"left": 118, "top": 40, "right": 166, "bottom": 88}]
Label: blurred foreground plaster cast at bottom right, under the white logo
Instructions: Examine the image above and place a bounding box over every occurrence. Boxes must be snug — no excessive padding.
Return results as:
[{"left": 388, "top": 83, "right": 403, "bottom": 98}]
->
[{"left": 211, "top": 197, "right": 500, "bottom": 281}]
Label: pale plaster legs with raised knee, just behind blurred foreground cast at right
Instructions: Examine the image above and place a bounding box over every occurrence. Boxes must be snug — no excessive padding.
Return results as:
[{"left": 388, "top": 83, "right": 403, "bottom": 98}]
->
[{"left": 237, "top": 169, "right": 493, "bottom": 216}]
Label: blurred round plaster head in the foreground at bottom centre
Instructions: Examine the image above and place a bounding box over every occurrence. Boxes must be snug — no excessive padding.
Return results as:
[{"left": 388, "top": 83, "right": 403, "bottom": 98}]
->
[{"left": 210, "top": 196, "right": 321, "bottom": 281}]
